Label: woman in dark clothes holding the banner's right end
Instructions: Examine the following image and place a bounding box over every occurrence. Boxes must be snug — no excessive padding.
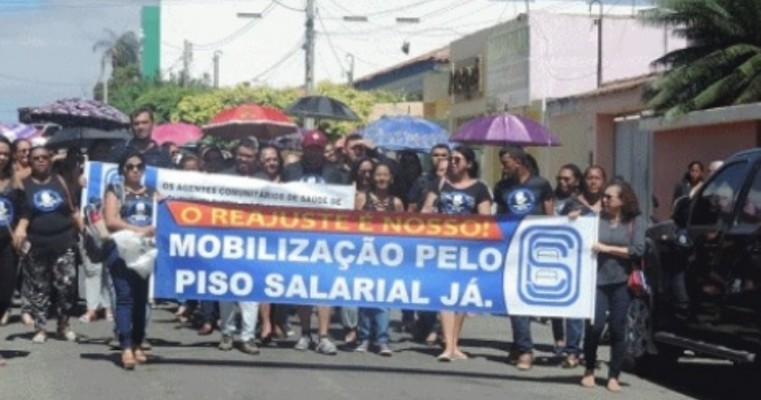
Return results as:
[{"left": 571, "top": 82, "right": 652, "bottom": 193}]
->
[{"left": 581, "top": 179, "right": 647, "bottom": 392}]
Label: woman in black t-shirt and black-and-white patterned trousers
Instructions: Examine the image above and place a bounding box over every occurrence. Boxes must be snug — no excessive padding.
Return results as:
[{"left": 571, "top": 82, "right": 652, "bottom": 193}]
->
[{"left": 16, "top": 146, "right": 83, "bottom": 343}]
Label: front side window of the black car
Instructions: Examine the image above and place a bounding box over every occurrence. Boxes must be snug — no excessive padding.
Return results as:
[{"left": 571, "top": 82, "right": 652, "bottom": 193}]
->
[{"left": 690, "top": 162, "right": 747, "bottom": 225}]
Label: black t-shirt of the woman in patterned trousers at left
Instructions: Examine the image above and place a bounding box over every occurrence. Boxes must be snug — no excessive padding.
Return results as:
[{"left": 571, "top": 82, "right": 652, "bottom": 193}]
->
[{"left": 23, "top": 175, "right": 76, "bottom": 251}]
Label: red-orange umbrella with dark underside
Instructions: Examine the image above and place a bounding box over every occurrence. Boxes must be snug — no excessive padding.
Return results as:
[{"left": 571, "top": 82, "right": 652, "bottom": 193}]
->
[{"left": 203, "top": 104, "right": 299, "bottom": 141}]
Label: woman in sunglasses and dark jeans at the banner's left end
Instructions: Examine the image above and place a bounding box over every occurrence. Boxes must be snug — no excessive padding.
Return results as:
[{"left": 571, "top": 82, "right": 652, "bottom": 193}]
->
[{"left": 103, "top": 153, "right": 156, "bottom": 369}]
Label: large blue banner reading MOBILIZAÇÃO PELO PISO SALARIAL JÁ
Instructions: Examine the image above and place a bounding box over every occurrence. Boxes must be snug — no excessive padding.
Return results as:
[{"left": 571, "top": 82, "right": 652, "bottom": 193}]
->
[{"left": 155, "top": 200, "right": 597, "bottom": 318}]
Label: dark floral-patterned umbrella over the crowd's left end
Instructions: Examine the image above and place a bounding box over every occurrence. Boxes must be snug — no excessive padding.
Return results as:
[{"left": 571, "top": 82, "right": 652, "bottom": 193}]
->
[{"left": 29, "top": 98, "right": 129, "bottom": 129}]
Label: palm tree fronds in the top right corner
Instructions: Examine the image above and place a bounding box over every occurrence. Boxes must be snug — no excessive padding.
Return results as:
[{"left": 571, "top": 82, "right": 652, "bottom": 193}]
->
[{"left": 643, "top": 0, "right": 761, "bottom": 117}]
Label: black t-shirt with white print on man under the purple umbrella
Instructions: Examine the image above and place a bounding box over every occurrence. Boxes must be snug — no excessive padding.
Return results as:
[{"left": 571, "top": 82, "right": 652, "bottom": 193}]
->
[{"left": 494, "top": 175, "right": 555, "bottom": 216}]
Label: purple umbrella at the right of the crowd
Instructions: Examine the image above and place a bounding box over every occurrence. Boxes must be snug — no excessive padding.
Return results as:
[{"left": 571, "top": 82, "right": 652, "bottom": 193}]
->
[{"left": 452, "top": 113, "right": 560, "bottom": 146}]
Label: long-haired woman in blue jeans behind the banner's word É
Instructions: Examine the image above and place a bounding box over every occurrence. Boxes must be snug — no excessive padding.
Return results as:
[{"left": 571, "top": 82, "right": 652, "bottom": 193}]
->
[{"left": 354, "top": 161, "right": 404, "bottom": 357}]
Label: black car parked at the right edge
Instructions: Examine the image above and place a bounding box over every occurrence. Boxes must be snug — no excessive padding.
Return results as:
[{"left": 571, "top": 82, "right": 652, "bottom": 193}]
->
[{"left": 627, "top": 148, "right": 761, "bottom": 373}]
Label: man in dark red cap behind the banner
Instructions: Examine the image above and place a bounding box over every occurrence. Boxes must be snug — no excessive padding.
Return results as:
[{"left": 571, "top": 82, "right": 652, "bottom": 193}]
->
[{"left": 282, "top": 129, "right": 349, "bottom": 355}]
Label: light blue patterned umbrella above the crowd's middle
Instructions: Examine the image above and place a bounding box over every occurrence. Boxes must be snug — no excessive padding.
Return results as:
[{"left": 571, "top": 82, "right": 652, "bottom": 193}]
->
[{"left": 361, "top": 116, "right": 449, "bottom": 152}]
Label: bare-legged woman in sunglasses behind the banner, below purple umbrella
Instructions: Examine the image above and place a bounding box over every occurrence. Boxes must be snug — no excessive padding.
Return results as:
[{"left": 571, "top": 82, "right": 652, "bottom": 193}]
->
[{"left": 422, "top": 146, "right": 492, "bottom": 361}]
